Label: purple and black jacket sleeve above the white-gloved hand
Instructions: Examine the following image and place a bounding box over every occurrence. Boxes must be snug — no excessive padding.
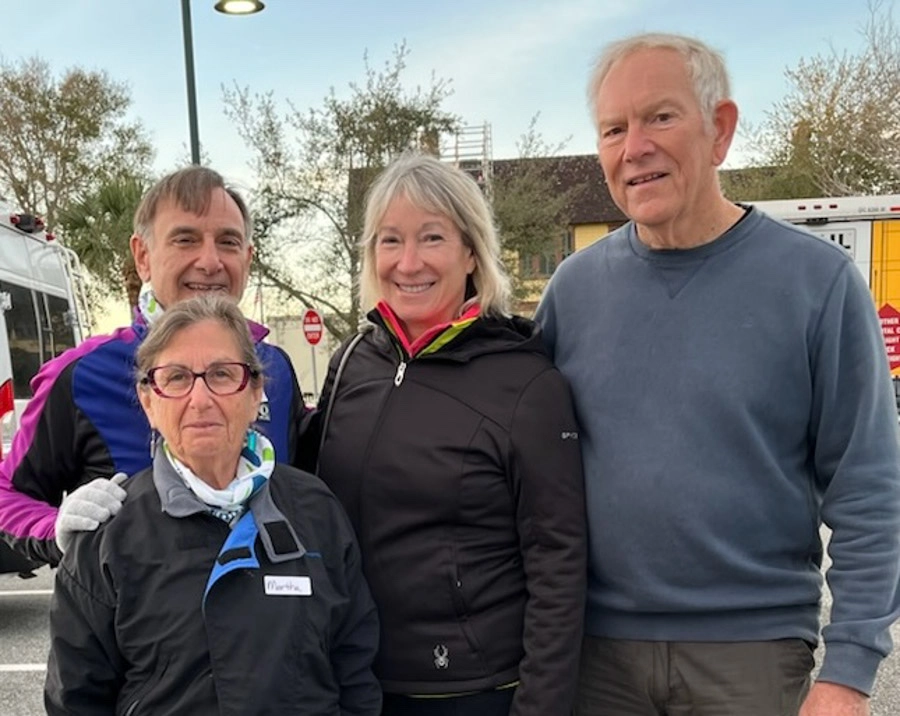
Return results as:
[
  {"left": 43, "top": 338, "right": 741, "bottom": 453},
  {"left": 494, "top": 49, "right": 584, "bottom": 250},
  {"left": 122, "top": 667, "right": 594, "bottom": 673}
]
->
[{"left": 0, "top": 359, "right": 85, "bottom": 565}]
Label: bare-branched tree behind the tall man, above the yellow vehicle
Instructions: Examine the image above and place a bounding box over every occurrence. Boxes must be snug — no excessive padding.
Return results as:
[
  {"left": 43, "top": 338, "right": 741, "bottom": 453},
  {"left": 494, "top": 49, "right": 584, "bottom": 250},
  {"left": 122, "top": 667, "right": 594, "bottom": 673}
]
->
[{"left": 740, "top": 0, "right": 900, "bottom": 199}]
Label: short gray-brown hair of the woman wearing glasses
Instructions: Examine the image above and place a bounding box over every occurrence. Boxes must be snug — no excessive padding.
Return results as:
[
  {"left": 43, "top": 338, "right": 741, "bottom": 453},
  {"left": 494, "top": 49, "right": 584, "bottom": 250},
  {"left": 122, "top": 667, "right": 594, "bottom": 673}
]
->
[{"left": 135, "top": 296, "right": 263, "bottom": 389}]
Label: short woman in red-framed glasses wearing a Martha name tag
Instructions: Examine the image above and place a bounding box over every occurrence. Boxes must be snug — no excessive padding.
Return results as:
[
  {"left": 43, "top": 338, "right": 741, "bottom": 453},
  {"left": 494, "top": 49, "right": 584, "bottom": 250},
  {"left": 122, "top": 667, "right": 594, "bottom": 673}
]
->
[{"left": 45, "top": 298, "right": 381, "bottom": 716}]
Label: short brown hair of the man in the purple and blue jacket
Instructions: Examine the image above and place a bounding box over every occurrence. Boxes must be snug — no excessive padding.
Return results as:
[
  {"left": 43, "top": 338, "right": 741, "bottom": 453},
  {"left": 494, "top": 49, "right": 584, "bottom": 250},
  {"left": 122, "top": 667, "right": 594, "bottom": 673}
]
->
[{"left": 134, "top": 166, "right": 253, "bottom": 244}]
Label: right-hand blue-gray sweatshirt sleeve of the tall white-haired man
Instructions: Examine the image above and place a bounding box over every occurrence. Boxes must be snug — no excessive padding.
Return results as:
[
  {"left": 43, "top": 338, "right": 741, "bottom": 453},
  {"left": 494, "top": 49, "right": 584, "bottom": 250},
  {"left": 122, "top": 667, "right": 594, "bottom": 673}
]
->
[{"left": 810, "top": 262, "right": 900, "bottom": 693}]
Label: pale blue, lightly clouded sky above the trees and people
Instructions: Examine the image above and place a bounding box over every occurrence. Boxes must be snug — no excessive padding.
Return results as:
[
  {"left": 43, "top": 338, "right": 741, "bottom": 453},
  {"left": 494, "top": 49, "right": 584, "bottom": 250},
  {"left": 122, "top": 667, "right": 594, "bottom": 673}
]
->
[{"left": 0, "top": 0, "right": 868, "bottom": 183}]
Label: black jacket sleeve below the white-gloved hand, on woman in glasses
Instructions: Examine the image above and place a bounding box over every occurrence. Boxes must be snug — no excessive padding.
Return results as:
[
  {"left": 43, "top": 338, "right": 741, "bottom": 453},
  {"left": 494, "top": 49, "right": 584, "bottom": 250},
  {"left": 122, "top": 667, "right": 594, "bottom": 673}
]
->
[{"left": 44, "top": 533, "right": 124, "bottom": 716}]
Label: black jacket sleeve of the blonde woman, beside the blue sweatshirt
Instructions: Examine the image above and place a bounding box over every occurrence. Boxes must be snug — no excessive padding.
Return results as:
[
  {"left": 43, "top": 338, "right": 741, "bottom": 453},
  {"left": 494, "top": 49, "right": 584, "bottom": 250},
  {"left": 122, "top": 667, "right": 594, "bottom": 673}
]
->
[{"left": 510, "top": 369, "right": 587, "bottom": 716}]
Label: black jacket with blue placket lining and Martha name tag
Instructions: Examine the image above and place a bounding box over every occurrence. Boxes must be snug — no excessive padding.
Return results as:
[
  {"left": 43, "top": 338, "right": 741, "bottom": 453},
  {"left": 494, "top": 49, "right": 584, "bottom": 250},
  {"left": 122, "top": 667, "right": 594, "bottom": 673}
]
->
[{"left": 45, "top": 458, "right": 381, "bottom": 716}]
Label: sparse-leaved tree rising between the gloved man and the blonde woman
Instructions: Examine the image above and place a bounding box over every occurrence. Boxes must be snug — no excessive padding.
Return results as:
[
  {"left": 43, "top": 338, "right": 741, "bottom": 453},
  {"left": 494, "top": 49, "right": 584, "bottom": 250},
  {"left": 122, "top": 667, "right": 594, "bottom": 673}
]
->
[{"left": 223, "top": 44, "right": 458, "bottom": 338}]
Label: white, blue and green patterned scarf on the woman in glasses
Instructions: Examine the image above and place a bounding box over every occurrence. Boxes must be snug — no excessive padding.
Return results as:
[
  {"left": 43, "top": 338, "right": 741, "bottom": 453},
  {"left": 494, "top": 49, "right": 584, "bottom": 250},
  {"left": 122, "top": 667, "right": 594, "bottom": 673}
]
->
[{"left": 163, "top": 430, "right": 275, "bottom": 525}]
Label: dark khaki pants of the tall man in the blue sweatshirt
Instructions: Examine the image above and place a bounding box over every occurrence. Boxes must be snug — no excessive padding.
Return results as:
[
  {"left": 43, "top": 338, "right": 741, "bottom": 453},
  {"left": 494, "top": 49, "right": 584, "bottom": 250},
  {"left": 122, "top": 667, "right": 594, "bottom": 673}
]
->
[{"left": 575, "top": 636, "right": 815, "bottom": 716}]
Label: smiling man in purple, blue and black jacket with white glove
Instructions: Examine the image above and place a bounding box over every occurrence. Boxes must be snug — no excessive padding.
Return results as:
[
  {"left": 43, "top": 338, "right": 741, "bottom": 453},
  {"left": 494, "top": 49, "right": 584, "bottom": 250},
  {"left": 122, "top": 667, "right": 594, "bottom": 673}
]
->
[{"left": 0, "top": 166, "right": 303, "bottom": 565}]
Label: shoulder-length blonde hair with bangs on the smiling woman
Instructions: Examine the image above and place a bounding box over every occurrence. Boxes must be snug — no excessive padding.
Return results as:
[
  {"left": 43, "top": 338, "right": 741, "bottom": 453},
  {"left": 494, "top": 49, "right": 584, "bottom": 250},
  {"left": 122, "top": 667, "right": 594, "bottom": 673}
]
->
[{"left": 359, "top": 151, "right": 510, "bottom": 316}]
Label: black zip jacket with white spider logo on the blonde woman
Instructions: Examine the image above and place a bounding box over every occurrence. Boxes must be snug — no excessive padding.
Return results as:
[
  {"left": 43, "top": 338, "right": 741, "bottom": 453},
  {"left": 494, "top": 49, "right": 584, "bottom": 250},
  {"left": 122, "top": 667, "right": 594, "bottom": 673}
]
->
[{"left": 305, "top": 311, "right": 586, "bottom": 716}]
